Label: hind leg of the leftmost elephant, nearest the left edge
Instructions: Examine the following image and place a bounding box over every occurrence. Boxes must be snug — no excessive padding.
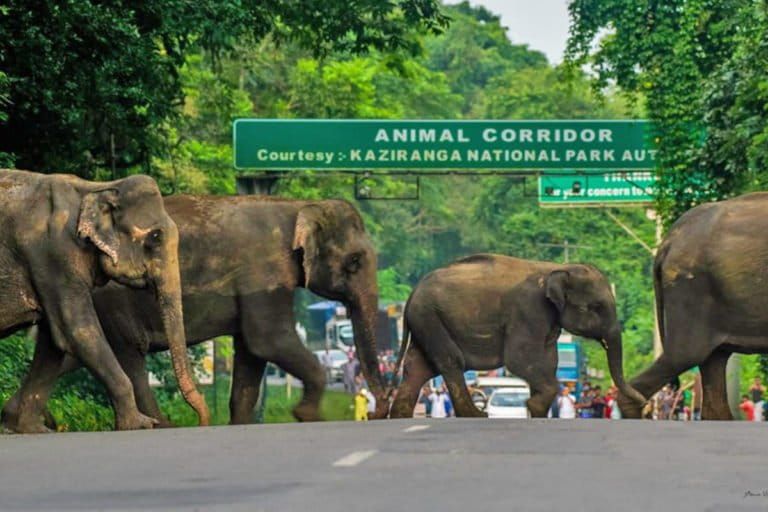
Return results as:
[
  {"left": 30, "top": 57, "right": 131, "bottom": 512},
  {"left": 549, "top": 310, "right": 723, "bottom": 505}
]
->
[{"left": 2, "top": 324, "right": 64, "bottom": 433}]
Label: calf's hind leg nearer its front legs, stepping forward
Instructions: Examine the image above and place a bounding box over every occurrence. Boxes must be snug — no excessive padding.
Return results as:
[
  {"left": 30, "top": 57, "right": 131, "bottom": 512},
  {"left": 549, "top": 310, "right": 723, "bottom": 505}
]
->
[{"left": 411, "top": 313, "right": 480, "bottom": 417}]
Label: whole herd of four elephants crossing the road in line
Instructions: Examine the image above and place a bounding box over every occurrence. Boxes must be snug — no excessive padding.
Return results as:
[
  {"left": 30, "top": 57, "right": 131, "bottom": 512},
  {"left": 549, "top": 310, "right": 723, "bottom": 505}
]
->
[{"left": 0, "top": 170, "right": 768, "bottom": 432}]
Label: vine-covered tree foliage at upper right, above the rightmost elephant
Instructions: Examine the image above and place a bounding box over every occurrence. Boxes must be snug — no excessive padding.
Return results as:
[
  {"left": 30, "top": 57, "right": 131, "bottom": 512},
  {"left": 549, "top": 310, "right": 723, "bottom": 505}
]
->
[{"left": 568, "top": 0, "right": 768, "bottom": 221}]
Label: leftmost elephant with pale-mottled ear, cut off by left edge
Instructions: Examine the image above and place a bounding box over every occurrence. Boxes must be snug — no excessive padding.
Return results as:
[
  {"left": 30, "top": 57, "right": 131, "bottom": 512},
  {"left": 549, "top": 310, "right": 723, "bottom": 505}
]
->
[{"left": 0, "top": 169, "right": 208, "bottom": 432}]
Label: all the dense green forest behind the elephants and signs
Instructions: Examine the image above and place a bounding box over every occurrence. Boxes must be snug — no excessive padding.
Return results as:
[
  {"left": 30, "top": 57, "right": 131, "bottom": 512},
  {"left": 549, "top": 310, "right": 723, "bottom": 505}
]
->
[{"left": 0, "top": 0, "right": 768, "bottom": 428}]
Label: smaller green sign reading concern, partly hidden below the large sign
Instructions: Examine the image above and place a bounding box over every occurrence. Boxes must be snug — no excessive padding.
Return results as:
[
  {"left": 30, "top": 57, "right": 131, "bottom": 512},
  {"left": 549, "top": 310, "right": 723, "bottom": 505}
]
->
[{"left": 539, "top": 171, "right": 656, "bottom": 206}]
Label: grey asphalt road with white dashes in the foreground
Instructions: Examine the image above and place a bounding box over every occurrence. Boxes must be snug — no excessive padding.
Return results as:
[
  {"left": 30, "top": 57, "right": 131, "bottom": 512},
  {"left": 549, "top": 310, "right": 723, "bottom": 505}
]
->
[{"left": 0, "top": 419, "right": 768, "bottom": 512}]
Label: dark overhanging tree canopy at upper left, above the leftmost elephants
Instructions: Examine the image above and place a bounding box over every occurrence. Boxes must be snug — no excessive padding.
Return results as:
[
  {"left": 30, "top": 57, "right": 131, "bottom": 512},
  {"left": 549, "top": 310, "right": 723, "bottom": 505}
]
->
[{"left": 0, "top": 0, "right": 447, "bottom": 177}]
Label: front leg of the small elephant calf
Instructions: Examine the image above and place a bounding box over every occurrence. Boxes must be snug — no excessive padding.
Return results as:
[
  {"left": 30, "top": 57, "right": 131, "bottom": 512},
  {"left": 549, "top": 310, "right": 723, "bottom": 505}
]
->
[{"left": 504, "top": 330, "right": 559, "bottom": 418}]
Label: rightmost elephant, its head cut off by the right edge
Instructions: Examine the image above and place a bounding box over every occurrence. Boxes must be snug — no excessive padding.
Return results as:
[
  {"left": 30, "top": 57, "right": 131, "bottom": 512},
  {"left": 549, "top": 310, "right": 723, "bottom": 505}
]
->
[{"left": 619, "top": 192, "right": 768, "bottom": 420}]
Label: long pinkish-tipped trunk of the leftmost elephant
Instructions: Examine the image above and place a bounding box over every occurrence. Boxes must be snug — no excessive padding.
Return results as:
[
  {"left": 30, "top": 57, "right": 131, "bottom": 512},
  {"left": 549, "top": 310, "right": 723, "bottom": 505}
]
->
[{"left": 153, "top": 232, "right": 210, "bottom": 426}]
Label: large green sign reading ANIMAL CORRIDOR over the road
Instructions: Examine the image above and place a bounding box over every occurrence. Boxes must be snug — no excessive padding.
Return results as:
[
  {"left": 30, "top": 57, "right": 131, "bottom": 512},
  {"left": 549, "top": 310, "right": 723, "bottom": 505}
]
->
[{"left": 233, "top": 119, "right": 656, "bottom": 172}]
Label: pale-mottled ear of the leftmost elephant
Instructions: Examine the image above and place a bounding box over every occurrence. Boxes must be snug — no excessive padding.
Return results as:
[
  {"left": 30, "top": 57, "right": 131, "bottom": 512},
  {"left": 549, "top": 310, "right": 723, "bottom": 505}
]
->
[{"left": 77, "top": 189, "right": 120, "bottom": 264}]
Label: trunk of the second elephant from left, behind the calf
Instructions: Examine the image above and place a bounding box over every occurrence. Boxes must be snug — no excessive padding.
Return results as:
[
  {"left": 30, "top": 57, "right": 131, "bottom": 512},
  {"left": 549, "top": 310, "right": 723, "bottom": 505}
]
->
[{"left": 349, "top": 289, "right": 388, "bottom": 418}]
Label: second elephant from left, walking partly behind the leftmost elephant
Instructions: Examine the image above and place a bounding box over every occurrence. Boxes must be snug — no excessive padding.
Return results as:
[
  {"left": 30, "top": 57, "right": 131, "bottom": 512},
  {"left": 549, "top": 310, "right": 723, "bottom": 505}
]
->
[{"left": 5, "top": 196, "right": 386, "bottom": 424}]
